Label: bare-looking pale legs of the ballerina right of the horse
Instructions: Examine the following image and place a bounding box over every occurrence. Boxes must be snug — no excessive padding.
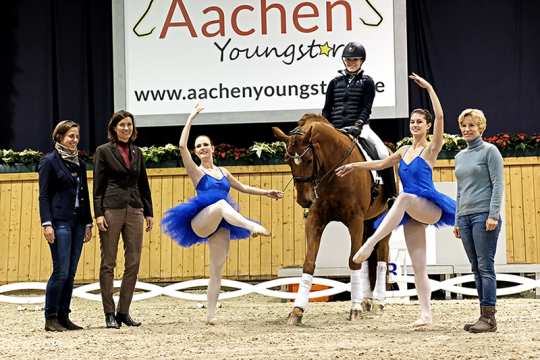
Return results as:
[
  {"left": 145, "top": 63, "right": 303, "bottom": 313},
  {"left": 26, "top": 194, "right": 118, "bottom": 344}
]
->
[{"left": 353, "top": 192, "right": 442, "bottom": 326}]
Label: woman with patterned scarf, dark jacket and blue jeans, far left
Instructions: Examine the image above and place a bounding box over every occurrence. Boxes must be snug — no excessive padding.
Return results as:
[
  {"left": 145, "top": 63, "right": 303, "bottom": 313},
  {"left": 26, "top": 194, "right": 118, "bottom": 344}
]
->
[{"left": 39, "top": 120, "right": 92, "bottom": 331}]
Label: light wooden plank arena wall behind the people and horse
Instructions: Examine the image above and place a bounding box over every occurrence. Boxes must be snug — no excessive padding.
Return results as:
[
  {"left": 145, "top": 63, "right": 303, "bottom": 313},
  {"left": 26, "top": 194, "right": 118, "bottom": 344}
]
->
[{"left": 0, "top": 157, "right": 540, "bottom": 284}]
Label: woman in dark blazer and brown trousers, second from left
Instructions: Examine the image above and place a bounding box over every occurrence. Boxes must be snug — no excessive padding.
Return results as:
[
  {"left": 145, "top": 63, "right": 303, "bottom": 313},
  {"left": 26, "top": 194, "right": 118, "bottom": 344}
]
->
[{"left": 94, "top": 111, "right": 153, "bottom": 329}]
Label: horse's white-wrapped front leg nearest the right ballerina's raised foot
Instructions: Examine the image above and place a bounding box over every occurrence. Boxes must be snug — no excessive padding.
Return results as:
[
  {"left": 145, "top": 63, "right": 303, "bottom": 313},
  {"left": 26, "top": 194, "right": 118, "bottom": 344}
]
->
[{"left": 346, "top": 217, "right": 371, "bottom": 321}]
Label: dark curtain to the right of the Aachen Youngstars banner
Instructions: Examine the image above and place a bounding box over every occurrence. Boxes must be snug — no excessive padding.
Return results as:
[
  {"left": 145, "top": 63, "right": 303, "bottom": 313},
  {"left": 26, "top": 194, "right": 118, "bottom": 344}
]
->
[{"left": 407, "top": 0, "right": 540, "bottom": 134}]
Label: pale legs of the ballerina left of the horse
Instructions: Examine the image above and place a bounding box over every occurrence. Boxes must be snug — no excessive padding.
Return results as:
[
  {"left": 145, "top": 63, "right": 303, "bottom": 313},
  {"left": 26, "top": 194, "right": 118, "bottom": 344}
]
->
[{"left": 191, "top": 200, "right": 268, "bottom": 325}]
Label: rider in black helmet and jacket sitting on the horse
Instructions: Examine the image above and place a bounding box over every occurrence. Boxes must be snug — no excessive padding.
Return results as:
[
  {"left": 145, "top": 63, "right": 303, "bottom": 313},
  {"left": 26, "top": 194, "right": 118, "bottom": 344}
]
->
[{"left": 322, "top": 42, "right": 397, "bottom": 199}]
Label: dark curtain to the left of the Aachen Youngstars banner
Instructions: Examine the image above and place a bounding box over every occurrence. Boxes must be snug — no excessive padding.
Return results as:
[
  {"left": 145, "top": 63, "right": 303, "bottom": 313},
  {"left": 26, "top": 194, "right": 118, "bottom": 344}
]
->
[{"left": 0, "top": 0, "right": 113, "bottom": 151}]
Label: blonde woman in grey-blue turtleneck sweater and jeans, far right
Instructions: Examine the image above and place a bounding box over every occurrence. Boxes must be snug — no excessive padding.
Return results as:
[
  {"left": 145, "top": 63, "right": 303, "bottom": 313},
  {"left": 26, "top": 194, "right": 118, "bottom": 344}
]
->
[{"left": 454, "top": 109, "right": 504, "bottom": 333}]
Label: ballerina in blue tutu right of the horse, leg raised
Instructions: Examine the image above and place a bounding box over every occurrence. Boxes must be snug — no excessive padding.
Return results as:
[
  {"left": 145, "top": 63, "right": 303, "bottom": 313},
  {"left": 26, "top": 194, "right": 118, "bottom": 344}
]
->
[{"left": 336, "top": 73, "right": 456, "bottom": 327}]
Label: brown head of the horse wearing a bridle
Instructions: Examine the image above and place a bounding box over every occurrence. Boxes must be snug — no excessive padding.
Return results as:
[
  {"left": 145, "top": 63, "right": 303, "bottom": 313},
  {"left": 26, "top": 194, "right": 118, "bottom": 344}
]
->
[{"left": 272, "top": 114, "right": 328, "bottom": 208}]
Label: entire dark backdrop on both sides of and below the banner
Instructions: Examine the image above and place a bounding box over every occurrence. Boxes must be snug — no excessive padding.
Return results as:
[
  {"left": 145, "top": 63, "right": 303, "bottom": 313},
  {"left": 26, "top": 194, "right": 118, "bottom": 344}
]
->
[{"left": 0, "top": 0, "right": 540, "bottom": 151}]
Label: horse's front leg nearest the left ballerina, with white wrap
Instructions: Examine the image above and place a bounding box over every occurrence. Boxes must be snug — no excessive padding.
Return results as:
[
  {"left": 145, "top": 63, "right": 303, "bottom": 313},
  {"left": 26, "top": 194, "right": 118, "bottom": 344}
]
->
[{"left": 287, "top": 211, "right": 324, "bottom": 325}]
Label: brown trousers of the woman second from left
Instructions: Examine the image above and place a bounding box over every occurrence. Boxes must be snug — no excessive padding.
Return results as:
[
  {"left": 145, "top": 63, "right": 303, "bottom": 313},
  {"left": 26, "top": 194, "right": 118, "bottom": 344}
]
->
[{"left": 99, "top": 207, "right": 144, "bottom": 314}]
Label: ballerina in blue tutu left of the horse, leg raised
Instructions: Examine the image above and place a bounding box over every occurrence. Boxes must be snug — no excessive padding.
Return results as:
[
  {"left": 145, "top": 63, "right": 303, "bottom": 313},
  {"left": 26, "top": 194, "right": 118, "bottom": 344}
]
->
[{"left": 161, "top": 104, "right": 283, "bottom": 325}]
